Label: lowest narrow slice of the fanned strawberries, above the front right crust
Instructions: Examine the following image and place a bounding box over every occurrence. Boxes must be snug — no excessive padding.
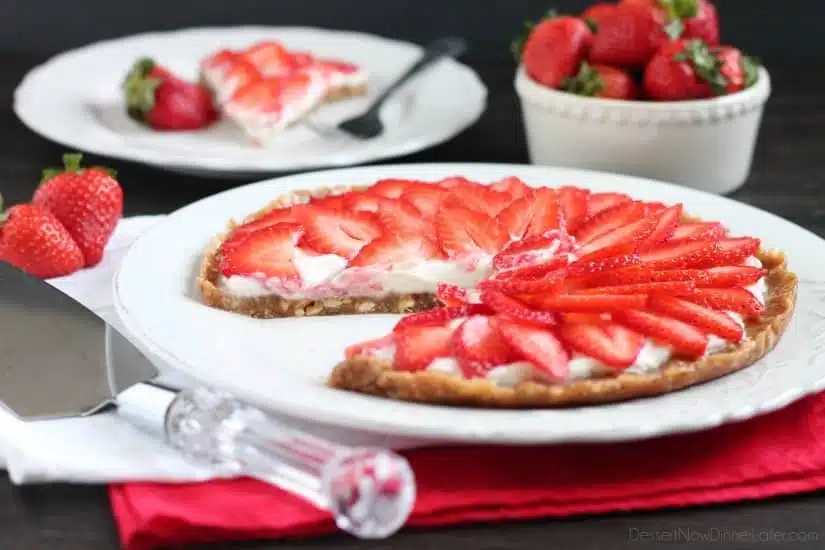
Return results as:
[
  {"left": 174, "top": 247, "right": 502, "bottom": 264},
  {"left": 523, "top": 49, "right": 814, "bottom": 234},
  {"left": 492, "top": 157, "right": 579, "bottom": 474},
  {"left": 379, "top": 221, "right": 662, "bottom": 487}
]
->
[{"left": 612, "top": 310, "right": 708, "bottom": 359}]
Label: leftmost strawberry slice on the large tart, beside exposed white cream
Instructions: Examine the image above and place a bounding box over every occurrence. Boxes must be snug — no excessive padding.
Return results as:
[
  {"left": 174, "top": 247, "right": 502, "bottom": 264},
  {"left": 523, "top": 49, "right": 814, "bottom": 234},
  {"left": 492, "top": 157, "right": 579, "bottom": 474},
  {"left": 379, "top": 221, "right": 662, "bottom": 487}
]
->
[{"left": 220, "top": 223, "right": 301, "bottom": 281}]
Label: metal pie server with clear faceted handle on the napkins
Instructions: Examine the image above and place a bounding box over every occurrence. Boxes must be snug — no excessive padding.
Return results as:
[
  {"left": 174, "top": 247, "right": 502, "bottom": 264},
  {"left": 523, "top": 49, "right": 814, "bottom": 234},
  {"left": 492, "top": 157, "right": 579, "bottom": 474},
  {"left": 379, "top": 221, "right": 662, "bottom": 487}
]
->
[{"left": 0, "top": 261, "right": 415, "bottom": 538}]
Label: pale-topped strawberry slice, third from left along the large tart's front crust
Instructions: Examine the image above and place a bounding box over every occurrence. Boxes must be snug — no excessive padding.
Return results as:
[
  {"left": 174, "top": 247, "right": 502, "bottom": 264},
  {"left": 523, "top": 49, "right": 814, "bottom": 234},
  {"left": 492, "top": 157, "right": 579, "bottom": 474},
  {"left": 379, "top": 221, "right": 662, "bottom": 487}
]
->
[{"left": 452, "top": 315, "right": 517, "bottom": 378}]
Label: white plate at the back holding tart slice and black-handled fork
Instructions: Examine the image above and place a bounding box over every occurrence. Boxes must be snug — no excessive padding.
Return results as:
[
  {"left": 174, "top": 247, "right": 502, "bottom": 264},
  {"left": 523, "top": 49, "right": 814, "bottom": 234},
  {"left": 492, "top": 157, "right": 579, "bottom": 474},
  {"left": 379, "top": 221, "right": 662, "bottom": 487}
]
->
[{"left": 14, "top": 27, "right": 487, "bottom": 177}]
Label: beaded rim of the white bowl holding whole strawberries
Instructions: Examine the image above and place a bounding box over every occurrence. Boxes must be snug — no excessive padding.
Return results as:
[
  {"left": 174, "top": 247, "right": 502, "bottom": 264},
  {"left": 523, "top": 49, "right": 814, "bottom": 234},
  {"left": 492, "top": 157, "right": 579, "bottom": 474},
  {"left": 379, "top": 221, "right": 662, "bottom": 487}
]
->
[{"left": 514, "top": 64, "right": 771, "bottom": 112}]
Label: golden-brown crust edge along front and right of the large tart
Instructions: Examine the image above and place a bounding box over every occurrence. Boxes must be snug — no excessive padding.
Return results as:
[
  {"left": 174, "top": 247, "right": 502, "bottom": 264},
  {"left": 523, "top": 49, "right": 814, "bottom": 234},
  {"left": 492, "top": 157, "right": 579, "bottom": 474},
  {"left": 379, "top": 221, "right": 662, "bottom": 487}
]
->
[{"left": 328, "top": 250, "right": 797, "bottom": 409}]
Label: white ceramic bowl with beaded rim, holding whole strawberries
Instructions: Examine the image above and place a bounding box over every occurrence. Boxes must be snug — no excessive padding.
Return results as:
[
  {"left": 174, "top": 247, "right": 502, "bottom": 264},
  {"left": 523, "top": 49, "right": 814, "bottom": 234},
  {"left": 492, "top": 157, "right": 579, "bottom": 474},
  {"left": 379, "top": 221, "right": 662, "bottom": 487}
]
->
[{"left": 515, "top": 67, "right": 771, "bottom": 194}]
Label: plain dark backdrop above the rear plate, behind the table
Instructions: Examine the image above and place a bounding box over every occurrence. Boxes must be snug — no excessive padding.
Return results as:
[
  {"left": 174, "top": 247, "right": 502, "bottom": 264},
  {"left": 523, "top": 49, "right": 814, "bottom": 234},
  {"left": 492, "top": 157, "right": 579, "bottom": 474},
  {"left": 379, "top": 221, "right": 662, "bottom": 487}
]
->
[{"left": 0, "top": 0, "right": 812, "bottom": 64}]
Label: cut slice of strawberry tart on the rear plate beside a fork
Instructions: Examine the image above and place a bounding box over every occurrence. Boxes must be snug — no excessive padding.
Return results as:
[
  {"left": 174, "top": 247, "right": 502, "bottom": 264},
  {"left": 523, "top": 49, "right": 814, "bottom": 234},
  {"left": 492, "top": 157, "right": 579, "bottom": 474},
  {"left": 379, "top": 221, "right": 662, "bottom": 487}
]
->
[{"left": 200, "top": 41, "right": 368, "bottom": 145}]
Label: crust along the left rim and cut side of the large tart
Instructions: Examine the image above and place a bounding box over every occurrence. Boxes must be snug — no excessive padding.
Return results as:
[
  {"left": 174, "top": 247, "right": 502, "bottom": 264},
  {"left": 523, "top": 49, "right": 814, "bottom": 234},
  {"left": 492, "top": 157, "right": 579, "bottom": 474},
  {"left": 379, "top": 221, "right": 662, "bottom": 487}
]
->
[{"left": 197, "top": 187, "right": 439, "bottom": 319}]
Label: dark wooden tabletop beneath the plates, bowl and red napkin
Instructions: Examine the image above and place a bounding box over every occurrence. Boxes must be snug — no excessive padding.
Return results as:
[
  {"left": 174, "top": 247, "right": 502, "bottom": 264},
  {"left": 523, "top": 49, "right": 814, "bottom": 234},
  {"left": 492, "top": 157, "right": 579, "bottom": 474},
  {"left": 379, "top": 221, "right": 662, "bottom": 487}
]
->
[{"left": 0, "top": 53, "right": 825, "bottom": 550}]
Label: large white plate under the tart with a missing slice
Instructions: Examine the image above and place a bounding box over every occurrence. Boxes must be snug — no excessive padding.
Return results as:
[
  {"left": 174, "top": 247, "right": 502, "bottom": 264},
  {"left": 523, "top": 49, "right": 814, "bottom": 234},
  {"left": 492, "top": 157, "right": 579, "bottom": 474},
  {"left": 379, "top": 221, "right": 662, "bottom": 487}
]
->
[{"left": 109, "top": 164, "right": 825, "bottom": 444}]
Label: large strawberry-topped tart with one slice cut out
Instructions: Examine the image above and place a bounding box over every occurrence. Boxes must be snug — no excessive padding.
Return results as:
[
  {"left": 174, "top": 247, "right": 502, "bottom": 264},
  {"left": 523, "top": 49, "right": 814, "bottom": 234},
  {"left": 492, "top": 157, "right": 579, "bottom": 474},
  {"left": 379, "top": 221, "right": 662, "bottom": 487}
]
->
[{"left": 199, "top": 177, "right": 797, "bottom": 408}]
